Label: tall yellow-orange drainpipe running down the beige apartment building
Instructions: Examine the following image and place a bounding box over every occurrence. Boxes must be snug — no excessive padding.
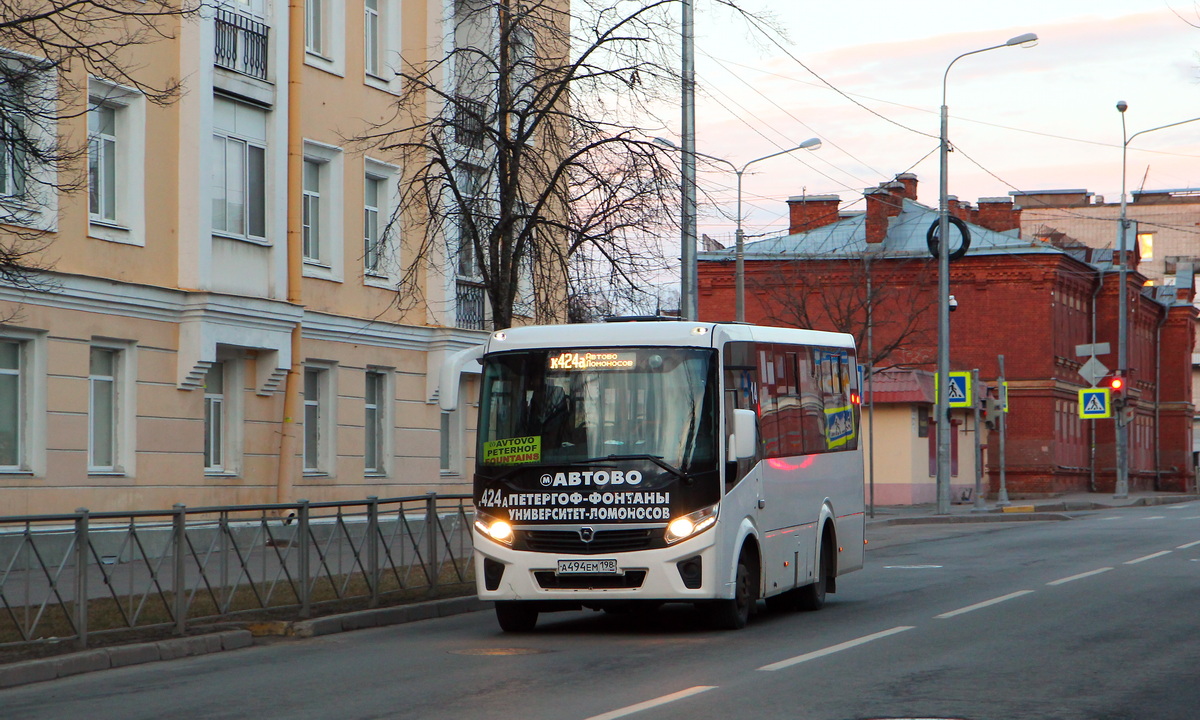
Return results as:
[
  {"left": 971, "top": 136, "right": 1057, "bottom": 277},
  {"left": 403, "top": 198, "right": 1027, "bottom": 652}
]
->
[{"left": 275, "top": 0, "right": 305, "bottom": 503}]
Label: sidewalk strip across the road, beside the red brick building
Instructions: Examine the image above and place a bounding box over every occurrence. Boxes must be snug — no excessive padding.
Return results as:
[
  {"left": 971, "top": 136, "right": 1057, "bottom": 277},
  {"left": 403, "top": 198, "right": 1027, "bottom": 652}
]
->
[{"left": 866, "top": 492, "right": 1200, "bottom": 526}]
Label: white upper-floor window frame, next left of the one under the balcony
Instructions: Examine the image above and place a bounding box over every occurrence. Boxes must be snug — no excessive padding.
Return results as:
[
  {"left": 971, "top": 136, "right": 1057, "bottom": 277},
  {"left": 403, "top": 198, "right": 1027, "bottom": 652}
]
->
[{"left": 88, "top": 78, "right": 146, "bottom": 246}]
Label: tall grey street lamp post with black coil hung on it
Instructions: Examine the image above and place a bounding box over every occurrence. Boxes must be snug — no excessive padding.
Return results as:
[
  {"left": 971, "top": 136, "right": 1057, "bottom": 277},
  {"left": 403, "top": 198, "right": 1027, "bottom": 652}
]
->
[{"left": 937, "top": 32, "right": 1038, "bottom": 515}]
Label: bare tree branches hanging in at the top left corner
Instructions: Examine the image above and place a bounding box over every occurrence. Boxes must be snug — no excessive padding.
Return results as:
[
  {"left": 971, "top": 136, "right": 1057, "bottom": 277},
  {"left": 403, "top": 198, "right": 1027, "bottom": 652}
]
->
[{"left": 0, "top": 0, "right": 199, "bottom": 287}]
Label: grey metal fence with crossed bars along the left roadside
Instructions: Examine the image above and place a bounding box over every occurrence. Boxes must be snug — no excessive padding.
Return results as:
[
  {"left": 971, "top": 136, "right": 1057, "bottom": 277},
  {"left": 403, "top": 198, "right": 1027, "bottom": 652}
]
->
[{"left": 0, "top": 493, "right": 474, "bottom": 649}]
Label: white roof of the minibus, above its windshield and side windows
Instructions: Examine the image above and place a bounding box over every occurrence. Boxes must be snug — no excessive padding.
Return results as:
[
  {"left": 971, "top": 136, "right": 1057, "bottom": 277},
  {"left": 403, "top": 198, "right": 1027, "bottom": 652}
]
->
[{"left": 485, "top": 320, "right": 854, "bottom": 353}]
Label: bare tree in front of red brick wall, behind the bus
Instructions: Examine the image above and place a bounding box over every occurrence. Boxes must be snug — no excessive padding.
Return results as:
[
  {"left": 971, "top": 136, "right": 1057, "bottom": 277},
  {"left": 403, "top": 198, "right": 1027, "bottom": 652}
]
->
[{"left": 746, "top": 251, "right": 937, "bottom": 368}]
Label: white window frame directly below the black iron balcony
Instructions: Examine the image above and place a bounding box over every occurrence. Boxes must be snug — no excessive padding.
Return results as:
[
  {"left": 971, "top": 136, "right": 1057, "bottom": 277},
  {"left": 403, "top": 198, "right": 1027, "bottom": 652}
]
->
[{"left": 209, "top": 95, "right": 270, "bottom": 245}]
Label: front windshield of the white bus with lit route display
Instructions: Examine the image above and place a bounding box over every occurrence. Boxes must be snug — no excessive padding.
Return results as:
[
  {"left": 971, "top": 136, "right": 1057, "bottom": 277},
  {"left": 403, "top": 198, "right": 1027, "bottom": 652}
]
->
[{"left": 478, "top": 348, "right": 716, "bottom": 473}]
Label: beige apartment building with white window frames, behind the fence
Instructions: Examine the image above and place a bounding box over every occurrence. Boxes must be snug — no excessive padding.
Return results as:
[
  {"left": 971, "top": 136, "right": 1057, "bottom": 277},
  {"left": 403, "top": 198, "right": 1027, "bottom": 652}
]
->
[{"left": 0, "top": 0, "right": 546, "bottom": 515}]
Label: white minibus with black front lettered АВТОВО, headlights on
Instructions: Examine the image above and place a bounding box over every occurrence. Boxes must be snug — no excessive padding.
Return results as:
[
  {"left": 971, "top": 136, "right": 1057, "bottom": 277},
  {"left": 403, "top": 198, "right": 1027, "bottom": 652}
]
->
[{"left": 444, "top": 320, "right": 864, "bottom": 631}]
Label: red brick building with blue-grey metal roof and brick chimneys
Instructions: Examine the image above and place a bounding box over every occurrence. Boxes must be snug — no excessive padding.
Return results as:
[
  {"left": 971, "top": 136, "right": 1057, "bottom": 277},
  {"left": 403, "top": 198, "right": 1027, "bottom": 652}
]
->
[{"left": 697, "top": 174, "right": 1196, "bottom": 497}]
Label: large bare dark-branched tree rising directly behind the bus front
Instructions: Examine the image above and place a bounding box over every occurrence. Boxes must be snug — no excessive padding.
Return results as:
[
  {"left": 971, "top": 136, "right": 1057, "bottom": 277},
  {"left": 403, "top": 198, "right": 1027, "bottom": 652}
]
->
[{"left": 362, "top": 0, "right": 678, "bottom": 329}]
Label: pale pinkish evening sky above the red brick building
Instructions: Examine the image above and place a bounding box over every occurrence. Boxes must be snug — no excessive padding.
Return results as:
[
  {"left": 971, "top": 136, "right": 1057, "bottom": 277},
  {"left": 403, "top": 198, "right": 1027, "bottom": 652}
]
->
[{"left": 668, "top": 0, "right": 1200, "bottom": 245}]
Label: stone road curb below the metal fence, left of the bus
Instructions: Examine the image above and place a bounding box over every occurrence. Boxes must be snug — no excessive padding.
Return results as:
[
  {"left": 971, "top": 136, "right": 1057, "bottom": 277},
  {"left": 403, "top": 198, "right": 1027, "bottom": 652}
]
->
[{"left": 0, "top": 595, "right": 492, "bottom": 689}]
